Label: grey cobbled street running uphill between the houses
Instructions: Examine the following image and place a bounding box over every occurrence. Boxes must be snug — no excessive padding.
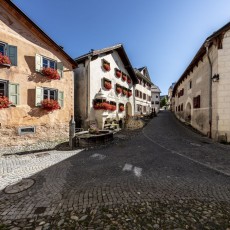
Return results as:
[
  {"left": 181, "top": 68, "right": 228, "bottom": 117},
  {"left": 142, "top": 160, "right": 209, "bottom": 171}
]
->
[{"left": 0, "top": 111, "right": 230, "bottom": 230}]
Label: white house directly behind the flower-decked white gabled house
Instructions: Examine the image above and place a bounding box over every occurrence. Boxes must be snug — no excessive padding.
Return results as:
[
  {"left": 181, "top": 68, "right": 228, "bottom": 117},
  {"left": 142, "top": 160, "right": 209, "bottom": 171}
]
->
[{"left": 134, "top": 67, "right": 153, "bottom": 114}]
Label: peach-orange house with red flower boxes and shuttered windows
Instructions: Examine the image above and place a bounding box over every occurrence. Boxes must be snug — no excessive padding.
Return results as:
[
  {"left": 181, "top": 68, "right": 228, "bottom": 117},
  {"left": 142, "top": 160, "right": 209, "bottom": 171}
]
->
[{"left": 0, "top": 0, "right": 76, "bottom": 150}]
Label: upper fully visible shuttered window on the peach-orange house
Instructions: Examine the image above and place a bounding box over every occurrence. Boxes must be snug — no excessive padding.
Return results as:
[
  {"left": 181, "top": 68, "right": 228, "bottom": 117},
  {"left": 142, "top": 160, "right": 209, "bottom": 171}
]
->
[{"left": 35, "top": 54, "right": 63, "bottom": 77}]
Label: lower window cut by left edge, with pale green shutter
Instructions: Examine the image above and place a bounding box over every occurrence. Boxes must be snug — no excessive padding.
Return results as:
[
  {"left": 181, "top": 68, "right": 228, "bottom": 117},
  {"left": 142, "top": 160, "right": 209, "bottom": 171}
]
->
[{"left": 0, "top": 80, "right": 19, "bottom": 105}]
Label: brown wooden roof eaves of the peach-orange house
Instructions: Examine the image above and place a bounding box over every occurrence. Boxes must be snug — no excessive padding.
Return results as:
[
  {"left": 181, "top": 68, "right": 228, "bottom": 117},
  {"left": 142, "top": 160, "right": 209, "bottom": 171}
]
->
[{"left": 1, "top": 0, "right": 77, "bottom": 68}]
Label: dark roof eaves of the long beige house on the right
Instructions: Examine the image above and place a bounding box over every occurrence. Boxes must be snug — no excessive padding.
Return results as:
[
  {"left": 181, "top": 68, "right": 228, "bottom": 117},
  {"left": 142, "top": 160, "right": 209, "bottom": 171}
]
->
[{"left": 173, "top": 22, "right": 230, "bottom": 96}]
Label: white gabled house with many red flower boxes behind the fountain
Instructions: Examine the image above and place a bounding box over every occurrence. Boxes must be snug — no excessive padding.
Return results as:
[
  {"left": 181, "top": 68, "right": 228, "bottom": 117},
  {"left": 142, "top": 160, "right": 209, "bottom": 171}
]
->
[{"left": 74, "top": 44, "right": 138, "bottom": 129}]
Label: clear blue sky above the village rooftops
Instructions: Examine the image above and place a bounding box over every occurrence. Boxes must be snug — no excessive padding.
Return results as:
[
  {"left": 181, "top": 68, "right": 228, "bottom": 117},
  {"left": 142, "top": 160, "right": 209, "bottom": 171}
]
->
[{"left": 13, "top": 0, "right": 230, "bottom": 94}]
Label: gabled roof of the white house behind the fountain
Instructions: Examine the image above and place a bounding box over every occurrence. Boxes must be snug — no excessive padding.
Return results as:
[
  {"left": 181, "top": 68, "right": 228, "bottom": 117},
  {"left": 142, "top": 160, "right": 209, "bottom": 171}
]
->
[{"left": 75, "top": 44, "right": 138, "bottom": 84}]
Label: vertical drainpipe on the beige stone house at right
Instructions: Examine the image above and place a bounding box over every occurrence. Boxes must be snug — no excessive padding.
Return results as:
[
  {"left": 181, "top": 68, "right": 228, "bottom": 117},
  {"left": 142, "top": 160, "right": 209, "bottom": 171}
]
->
[{"left": 205, "top": 40, "right": 212, "bottom": 138}]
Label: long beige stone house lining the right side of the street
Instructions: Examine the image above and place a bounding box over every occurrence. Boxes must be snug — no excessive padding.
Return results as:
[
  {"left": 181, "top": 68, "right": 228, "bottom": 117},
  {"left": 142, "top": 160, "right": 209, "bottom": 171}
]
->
[{"left": 173, "top": 23, "right": 230, "bottom": 142}]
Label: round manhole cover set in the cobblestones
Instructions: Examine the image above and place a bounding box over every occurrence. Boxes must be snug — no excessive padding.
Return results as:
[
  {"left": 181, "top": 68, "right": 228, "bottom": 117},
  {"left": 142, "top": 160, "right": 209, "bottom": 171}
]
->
[{"left": 4, "top": 178, "right": 35, "bottom": 194}]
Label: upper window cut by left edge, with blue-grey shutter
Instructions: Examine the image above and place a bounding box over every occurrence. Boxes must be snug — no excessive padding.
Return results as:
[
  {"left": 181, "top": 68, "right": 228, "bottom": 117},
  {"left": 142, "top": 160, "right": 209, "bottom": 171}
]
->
[{"left": 0, "top": 42, "right": 17, "bottom": 66}]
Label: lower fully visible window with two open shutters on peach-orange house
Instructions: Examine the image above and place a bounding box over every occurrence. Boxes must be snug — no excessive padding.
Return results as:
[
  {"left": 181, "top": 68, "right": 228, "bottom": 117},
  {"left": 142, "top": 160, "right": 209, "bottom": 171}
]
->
[{"left": 35, "top": 87, "right": 64, "bottom": 107}]
